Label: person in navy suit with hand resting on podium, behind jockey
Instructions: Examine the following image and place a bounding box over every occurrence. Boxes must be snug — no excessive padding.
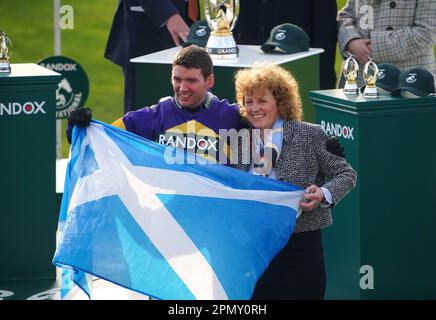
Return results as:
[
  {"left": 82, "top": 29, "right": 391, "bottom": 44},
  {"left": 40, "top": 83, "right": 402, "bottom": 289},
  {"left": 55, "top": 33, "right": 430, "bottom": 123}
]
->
[{"left": 104, "top": 0, "right": 195, "bottom": 113}]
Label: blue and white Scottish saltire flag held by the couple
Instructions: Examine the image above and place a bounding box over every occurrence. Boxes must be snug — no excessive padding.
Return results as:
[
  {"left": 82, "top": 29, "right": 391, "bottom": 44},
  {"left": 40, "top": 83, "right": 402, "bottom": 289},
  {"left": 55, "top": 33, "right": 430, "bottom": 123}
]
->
[{"left": 53, "top": 122, "right": 303, "bottom": 299}]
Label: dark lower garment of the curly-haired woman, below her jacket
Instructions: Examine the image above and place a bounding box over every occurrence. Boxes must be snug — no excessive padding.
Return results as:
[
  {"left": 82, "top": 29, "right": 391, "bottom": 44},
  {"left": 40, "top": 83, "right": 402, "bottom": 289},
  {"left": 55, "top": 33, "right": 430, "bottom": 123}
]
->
[{"left": 252, "top": 230, "right": 326, "bottom": 300}]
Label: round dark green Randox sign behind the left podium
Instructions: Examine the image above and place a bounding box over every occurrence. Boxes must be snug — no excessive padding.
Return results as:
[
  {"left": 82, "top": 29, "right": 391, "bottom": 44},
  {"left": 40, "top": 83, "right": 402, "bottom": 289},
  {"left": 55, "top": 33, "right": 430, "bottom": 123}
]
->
[{"left": 38, "top": 56, "right": 89, "bottom": 119}]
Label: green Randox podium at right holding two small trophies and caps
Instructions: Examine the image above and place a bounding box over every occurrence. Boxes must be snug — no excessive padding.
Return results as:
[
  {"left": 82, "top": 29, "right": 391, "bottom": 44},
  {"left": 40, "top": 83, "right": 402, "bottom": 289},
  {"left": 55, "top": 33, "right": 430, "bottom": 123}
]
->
[{"left": 310, "top": 90, "right": 436, "bottom": 300}]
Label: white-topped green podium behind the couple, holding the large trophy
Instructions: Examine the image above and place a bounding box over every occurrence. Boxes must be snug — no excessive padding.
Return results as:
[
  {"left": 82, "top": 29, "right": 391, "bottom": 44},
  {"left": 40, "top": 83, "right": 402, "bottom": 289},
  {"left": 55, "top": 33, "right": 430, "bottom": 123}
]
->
[{"left": 131, "top": 45, "right": 324, "bottom": 122}]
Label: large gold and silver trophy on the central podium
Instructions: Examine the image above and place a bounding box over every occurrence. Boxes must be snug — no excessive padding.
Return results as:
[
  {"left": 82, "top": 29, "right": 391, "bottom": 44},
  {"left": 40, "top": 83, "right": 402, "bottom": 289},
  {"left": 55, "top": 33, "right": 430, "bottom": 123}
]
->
[{"left": 204, "top": 0, "right": 239, "bottom": 61}]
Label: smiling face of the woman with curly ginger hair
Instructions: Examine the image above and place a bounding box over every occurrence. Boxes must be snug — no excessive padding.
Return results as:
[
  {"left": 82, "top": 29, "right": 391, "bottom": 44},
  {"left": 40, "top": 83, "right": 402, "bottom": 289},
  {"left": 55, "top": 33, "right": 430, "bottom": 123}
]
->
[{"left": 244, "top": 89, "right": 279, "bottom": 129}]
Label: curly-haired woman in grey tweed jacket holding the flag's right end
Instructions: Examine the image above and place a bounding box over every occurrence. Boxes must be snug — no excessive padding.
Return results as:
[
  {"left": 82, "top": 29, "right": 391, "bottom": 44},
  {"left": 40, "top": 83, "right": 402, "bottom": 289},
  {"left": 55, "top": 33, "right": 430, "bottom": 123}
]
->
[{"left": 235, "top": 65, "right": 356, "bottom": 300}]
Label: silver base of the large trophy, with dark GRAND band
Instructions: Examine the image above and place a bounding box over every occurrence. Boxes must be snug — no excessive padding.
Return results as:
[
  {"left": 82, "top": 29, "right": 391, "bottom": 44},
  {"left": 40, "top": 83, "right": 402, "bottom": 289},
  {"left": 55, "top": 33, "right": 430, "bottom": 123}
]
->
[{"left": 206, "top": 32, "right": 239, "bottom": 62}]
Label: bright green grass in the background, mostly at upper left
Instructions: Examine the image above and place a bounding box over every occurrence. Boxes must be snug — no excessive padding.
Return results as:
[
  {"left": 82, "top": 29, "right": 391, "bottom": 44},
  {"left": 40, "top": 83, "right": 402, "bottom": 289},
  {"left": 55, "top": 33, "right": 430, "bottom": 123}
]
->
[{"left": 0, "top": 0, "right": 432, "bottom": 157}]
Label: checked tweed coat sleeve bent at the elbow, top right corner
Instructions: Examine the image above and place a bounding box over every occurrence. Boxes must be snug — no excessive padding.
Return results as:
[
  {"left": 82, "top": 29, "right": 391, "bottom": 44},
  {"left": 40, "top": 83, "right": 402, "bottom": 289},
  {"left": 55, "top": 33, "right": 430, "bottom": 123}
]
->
[{"left": 371, "top": 0, "right": 436, "bottom": 62}]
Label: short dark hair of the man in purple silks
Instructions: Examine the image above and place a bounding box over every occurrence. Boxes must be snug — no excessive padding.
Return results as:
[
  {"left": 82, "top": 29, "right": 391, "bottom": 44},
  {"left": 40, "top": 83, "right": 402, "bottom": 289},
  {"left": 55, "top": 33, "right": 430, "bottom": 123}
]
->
[{"left": 173, "top": 45, "right": 213, "bottom": 80}]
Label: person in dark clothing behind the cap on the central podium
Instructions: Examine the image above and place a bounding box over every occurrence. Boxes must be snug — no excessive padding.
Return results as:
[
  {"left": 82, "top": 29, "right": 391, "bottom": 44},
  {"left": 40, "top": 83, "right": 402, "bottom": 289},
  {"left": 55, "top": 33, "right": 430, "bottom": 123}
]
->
[{"left": 233, "top": 0, "right": 338, "bottom": 89}]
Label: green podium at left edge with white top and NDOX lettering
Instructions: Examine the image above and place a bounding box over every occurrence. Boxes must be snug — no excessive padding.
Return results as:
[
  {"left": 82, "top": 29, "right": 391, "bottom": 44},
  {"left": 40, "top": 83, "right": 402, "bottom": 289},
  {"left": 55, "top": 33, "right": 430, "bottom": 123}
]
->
[{"left": 0, "top": 63, "right": 60, "bottom": 287}]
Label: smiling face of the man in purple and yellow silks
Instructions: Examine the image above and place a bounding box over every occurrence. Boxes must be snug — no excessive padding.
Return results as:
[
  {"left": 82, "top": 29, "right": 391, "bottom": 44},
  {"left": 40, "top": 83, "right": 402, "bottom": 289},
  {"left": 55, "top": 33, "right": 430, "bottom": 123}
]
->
[{"left": 171, "top": 65, "right": 214, "bottom": 108}]
